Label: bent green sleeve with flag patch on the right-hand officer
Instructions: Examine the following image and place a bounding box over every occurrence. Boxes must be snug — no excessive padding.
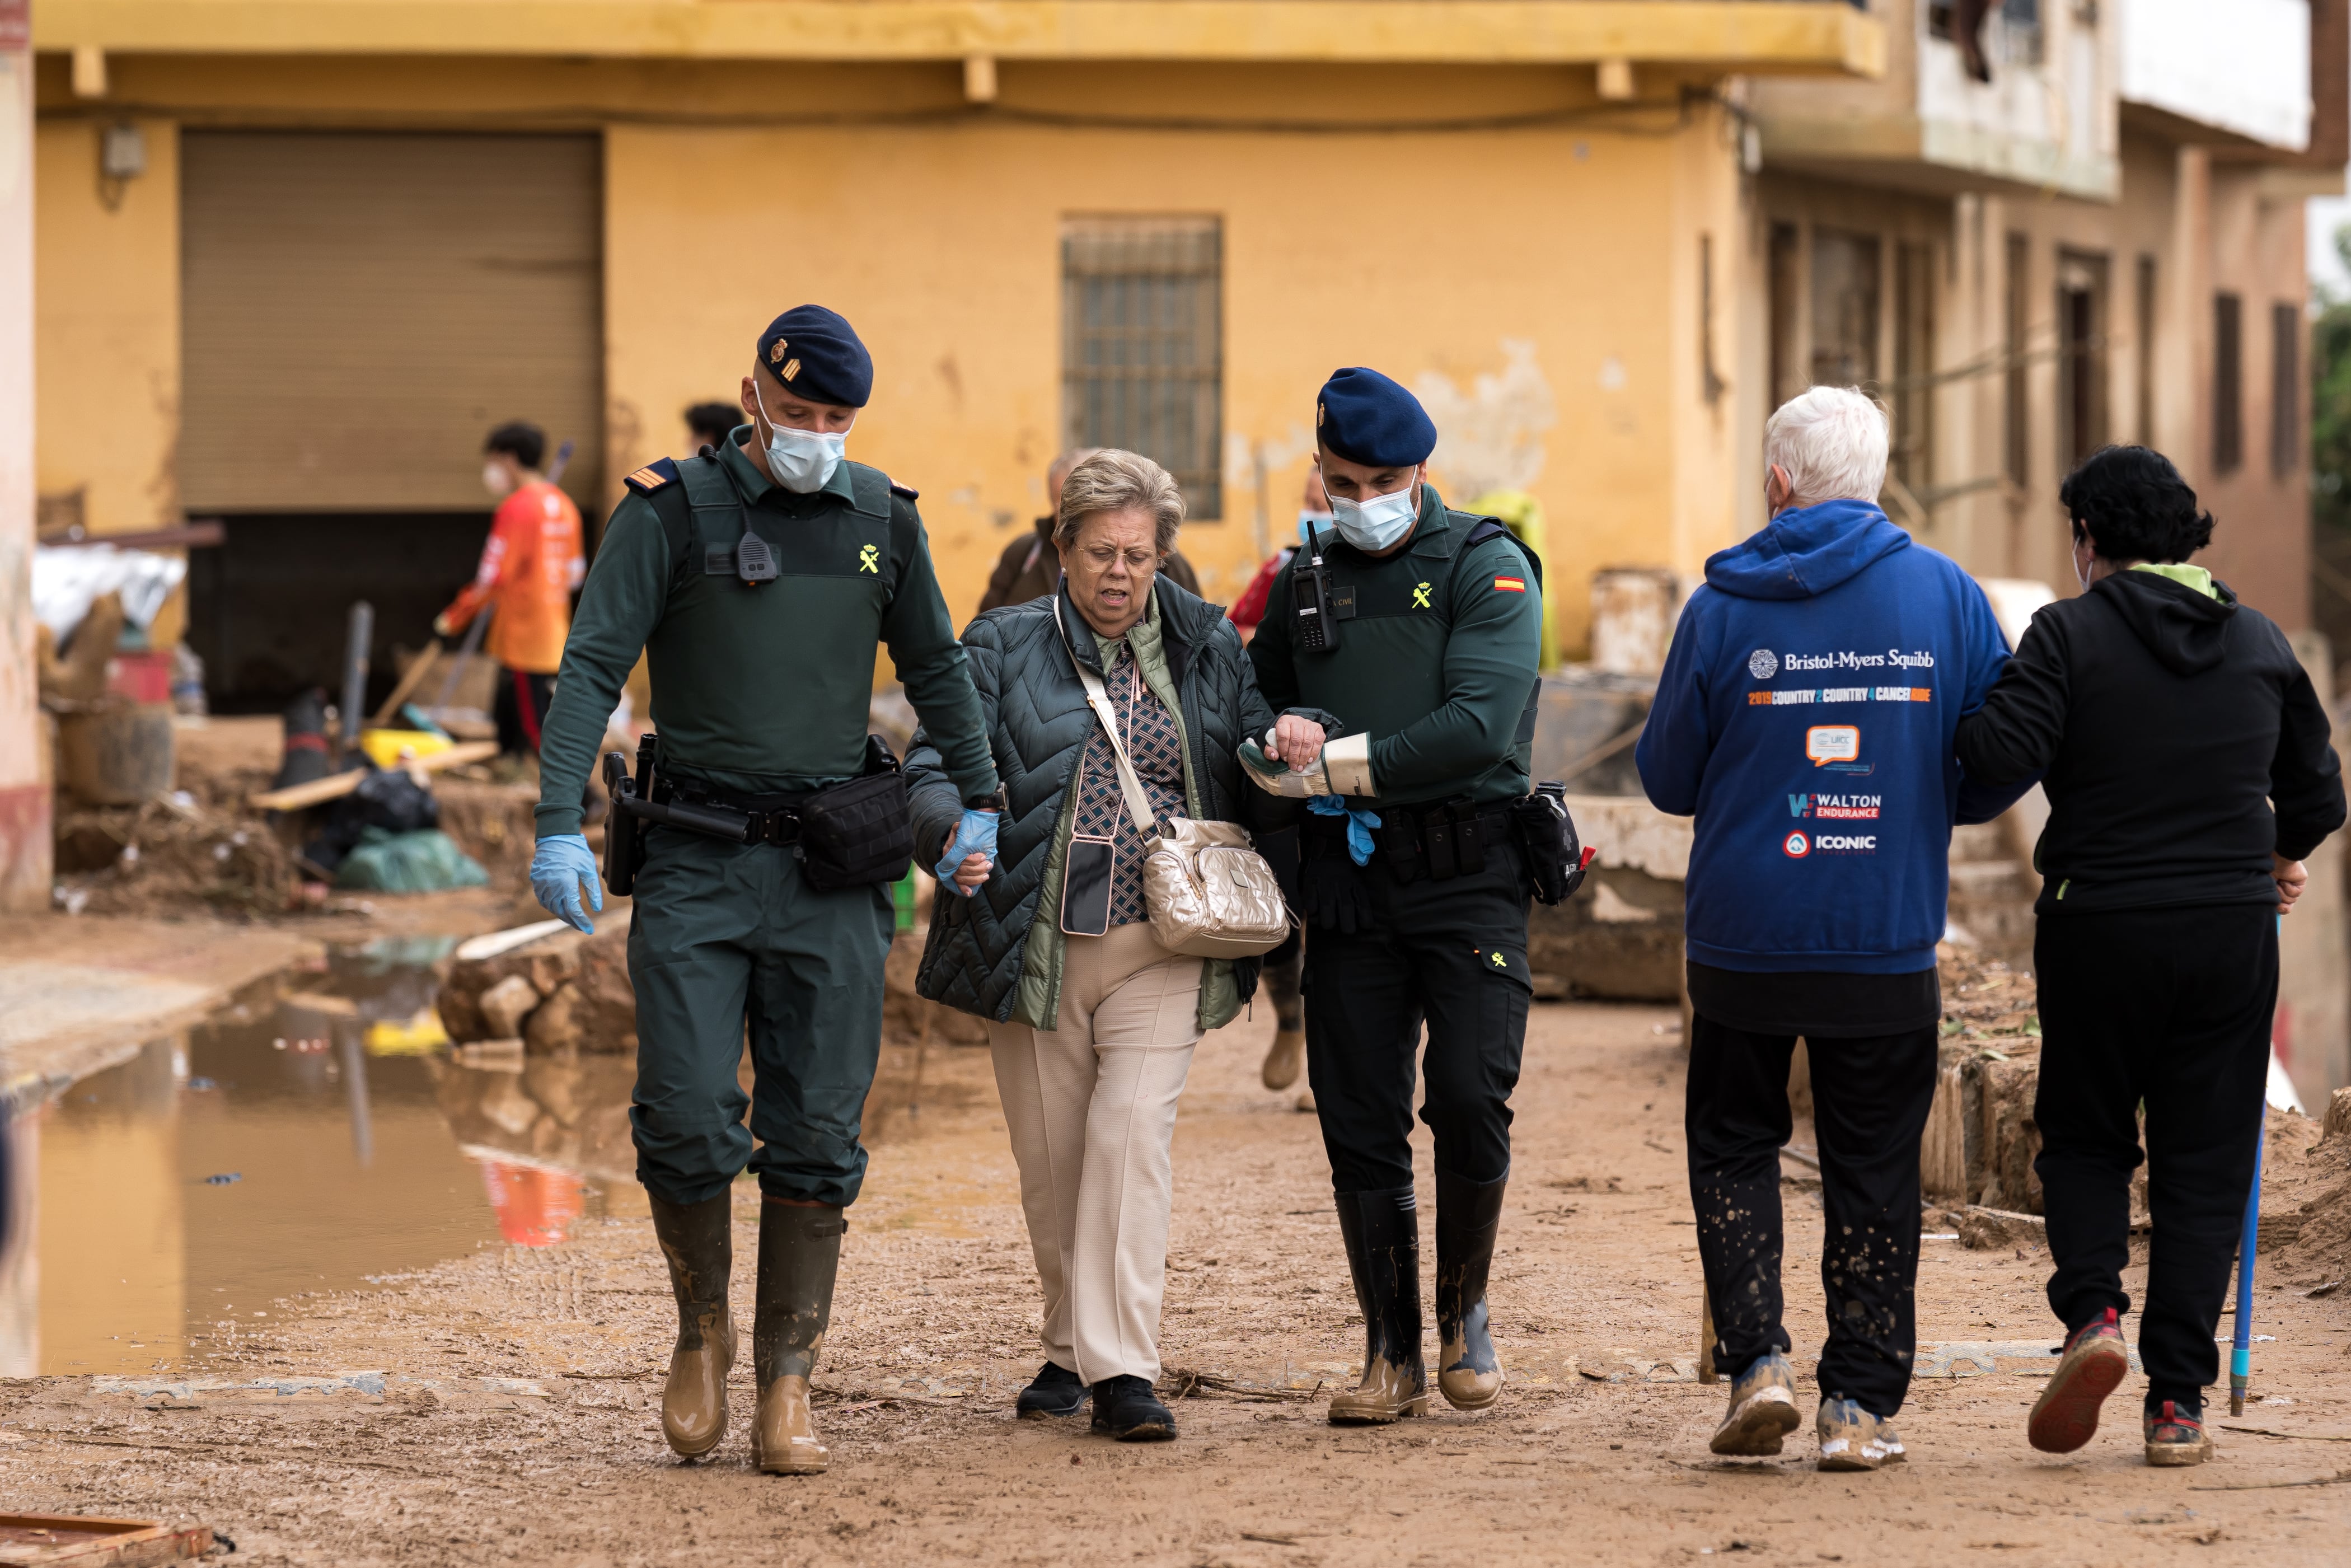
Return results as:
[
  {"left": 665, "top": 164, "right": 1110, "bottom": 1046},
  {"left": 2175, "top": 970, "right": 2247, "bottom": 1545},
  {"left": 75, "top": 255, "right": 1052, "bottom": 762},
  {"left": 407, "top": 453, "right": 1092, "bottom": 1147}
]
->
[{"left": 1373, "top": 539, "right": 1542, "bottom": 794}]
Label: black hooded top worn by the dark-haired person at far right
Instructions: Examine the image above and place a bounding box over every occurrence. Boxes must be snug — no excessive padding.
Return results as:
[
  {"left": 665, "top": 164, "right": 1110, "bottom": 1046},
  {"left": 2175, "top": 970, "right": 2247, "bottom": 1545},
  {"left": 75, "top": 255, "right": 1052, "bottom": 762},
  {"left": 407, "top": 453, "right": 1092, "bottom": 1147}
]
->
[{"left": 1956, "top": 571, "right": 2344, "bottom": 915}]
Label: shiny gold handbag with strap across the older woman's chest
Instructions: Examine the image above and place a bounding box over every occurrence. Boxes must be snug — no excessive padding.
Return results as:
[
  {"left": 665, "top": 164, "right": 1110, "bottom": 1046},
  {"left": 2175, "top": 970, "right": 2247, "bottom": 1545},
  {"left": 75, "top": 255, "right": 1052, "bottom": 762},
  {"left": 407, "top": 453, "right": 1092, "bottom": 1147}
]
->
[{"left": 1053, "top": 602, "right": 1291, "bottom": 959}]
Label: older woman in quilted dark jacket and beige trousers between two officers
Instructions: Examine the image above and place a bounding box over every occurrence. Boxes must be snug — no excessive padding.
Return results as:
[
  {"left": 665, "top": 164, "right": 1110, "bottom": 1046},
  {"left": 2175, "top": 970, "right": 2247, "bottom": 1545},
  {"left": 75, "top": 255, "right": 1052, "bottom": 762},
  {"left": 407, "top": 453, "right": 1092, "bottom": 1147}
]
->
[{"left": 907, "top": 451, "right": 1321, "bottom": 1441}]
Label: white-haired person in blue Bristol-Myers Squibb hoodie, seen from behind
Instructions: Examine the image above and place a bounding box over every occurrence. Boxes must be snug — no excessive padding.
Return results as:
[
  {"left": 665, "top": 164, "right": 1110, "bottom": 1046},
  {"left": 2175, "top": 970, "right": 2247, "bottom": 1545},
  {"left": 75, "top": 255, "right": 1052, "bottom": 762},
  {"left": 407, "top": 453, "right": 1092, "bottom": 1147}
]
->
[{"left": 1634, "top": 386, "right": 2031, "bottom": 1469}]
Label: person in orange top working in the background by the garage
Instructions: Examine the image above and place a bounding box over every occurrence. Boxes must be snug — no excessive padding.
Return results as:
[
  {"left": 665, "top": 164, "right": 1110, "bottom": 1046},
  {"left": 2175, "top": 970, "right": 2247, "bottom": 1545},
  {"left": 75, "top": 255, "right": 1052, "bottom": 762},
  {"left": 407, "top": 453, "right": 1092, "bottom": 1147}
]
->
[{"left": 433, "top": 421, "right": 588, "bottom": 752}]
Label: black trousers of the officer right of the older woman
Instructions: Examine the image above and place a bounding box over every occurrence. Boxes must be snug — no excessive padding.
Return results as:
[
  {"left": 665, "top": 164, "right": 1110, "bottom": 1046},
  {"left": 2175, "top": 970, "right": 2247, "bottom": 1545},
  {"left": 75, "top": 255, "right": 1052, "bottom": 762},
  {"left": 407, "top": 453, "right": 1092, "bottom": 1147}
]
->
[{"left": 1300, "top": 844, "right": 1533, "bottom": 1192}]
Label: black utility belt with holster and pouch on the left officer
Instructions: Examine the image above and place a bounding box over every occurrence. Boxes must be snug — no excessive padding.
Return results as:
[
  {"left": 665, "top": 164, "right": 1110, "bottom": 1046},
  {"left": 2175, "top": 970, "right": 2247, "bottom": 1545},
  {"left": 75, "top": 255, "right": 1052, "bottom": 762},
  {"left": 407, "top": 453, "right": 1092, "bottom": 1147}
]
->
[{"left": 604, "top": 736, "right": 915, "bottom": 896}]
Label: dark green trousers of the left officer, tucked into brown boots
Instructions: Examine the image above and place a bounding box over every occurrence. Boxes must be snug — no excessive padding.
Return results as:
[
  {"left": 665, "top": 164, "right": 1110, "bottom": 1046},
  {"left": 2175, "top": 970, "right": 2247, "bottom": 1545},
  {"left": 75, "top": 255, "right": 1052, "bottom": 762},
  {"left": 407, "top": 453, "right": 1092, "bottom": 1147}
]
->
[{"left": 627, "top": 827, "right": 896, "bottom": 1206}]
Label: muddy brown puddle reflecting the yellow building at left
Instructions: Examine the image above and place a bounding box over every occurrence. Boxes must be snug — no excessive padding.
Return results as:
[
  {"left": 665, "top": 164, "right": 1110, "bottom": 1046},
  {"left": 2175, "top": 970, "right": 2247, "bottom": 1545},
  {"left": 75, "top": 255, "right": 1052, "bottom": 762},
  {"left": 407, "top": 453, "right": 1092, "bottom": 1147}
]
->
[{"left": 0, "top": 938, "right": 644, "bottom": 1375}]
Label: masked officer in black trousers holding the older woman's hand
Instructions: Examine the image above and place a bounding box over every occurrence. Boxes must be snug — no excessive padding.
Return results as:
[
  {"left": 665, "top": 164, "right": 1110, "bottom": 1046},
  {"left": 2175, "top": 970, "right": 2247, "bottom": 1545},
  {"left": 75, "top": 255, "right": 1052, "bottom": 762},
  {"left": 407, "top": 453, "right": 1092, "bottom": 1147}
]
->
[{"left": 1244, "top": 369, "right": 1542, "bottom": 1422}]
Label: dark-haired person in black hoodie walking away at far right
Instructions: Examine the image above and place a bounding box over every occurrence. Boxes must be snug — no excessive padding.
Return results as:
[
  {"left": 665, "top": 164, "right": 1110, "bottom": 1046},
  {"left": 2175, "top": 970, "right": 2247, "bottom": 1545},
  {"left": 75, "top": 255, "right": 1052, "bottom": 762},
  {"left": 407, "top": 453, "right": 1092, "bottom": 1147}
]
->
[{"left": 1956, "top": 447, "right": 2344, "bottom": 1464}]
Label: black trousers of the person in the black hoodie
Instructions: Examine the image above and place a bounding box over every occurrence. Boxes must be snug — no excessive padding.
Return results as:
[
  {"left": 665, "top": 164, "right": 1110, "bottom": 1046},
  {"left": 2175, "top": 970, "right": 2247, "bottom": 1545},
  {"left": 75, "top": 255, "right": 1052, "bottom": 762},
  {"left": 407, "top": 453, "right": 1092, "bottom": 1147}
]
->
[{"left": 2034, "top": 905, "right": 2278, "bottom": 1406}]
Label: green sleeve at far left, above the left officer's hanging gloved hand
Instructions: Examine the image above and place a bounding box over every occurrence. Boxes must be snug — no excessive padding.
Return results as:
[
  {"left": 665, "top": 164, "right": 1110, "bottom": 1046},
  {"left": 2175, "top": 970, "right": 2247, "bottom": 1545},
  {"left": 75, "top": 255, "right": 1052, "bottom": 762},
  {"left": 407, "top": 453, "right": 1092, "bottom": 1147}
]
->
[{"left": 536, "top": 492, "right": 670, "bottom": 839}]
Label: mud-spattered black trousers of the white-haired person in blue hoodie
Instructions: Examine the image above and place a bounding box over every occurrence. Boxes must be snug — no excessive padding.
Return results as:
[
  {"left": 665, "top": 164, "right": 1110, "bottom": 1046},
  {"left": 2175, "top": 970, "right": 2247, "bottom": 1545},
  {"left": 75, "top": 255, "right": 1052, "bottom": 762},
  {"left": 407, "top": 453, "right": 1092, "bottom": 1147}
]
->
[{"left": 1683, "top": 1013, "right": 1935, "bottom": 1417}]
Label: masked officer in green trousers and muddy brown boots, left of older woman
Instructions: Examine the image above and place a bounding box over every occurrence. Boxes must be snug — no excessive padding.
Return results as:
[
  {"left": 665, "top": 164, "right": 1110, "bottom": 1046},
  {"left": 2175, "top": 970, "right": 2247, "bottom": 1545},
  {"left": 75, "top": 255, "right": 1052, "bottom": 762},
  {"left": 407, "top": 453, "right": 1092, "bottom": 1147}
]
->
[{"left": 531, "top": 306, "right": 997, "bottom": 1474}]
